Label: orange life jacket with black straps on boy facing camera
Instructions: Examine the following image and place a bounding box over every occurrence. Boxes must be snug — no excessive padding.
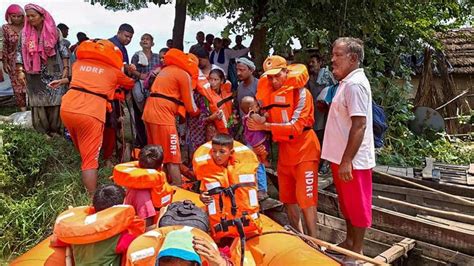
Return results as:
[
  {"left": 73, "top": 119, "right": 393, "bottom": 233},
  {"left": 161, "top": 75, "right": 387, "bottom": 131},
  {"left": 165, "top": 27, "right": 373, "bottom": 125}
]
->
[{"left": 193, "top": 141, "right": 262, "bottom": 240}]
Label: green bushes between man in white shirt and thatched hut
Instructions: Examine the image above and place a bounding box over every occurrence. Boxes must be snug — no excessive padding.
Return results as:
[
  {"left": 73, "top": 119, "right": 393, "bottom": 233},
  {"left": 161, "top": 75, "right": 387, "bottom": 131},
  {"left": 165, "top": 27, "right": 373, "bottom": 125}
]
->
[{"left": 371, "top": 77, "right": 474, "bottom": 167}]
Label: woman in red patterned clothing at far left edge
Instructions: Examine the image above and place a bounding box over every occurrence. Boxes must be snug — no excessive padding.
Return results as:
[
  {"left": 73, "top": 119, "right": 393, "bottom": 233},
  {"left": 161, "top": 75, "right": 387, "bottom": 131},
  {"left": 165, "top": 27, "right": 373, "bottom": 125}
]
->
[{"left": 0, "top": 4, "right": 26, "bottom": 111}]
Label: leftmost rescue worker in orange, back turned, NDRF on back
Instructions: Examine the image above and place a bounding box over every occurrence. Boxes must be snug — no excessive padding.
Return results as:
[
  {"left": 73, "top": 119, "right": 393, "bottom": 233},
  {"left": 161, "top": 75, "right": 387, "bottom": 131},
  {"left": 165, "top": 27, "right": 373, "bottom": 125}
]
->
[{"left": 50, "top": 40, "right": 134, "bottom": 195}]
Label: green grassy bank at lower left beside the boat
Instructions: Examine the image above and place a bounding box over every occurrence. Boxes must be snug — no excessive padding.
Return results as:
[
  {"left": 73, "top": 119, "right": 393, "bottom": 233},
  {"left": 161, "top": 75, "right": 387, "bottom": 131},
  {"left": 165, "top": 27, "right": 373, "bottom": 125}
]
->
[{"left": 0, "top": 125, "right": 111, "bottom": 261}]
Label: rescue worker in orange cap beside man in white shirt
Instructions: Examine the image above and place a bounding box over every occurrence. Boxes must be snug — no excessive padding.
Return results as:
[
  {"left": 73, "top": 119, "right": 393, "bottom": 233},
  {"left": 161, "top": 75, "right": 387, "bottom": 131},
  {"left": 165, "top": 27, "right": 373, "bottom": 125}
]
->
[{"left": 248, "top": 56, "right": 321, "bottom": 237}]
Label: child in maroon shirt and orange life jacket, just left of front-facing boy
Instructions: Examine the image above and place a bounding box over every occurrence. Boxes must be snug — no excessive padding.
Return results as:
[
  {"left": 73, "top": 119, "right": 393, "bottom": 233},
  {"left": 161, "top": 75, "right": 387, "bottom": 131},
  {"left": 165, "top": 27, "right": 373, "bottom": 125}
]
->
[{"left": 113, "top": 145, "right": 173, "bottom": 227}]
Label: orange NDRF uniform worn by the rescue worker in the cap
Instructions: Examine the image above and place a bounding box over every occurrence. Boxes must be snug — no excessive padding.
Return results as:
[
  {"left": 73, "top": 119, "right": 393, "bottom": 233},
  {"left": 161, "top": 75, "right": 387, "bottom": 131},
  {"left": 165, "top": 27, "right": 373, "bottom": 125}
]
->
[{"left": 257, "top": 86, "right": 321, "bottom": 208}]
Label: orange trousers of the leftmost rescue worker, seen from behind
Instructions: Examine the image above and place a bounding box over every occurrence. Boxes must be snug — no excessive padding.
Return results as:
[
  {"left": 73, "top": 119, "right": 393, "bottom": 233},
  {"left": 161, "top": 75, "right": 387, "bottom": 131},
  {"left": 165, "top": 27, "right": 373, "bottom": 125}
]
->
[{"left": 61, "top": 110, "right": 104, "bottom": 171}]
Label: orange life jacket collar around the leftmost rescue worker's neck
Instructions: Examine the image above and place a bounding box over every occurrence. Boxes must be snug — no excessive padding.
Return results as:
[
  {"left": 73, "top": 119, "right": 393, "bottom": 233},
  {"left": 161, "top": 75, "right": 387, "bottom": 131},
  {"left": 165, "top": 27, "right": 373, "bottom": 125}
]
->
[{"left": 76, "top": 40, "right": 123, "bottom": 69}]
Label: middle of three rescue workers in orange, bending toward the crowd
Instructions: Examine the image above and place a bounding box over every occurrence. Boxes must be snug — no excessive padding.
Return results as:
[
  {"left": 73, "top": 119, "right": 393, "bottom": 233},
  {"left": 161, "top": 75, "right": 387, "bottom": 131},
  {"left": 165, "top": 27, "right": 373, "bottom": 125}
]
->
[{"left": 143, "top": 49, "right": 199, "bottom": 185}]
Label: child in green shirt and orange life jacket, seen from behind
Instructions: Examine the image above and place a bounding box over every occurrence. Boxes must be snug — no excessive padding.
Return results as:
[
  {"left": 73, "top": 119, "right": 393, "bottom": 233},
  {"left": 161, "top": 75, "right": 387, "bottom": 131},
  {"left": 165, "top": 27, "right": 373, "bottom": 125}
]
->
[{"left": 52, "top": 184, "right": 145, "bottom": 266}]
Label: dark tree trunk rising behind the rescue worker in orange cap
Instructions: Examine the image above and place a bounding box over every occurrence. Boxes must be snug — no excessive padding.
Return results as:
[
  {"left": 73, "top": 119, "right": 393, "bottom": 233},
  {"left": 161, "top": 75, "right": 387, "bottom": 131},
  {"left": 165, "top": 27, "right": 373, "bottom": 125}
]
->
[{"left": 250, "top": 0, "right": 268, "bottom": 72}]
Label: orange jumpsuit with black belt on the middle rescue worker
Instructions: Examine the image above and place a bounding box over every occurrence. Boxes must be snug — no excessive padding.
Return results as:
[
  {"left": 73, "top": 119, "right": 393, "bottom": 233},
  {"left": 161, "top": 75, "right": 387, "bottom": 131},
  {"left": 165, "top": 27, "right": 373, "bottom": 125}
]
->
[{"left": 143, "top": 65, "right": 199, "bottom": 164}]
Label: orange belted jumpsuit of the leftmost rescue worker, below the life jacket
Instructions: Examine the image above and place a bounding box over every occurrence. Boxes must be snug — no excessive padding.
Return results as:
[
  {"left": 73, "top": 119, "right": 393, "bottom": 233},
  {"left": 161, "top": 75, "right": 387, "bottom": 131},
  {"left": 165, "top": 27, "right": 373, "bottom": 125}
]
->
[{"left": 61, "top": 59, "right": 134, "bottom": 170}]
